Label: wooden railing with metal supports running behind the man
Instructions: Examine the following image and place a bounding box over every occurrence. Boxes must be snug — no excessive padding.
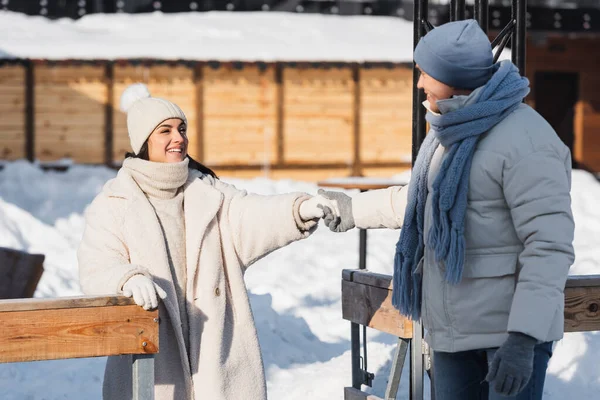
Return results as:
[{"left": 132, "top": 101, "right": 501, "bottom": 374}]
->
[{"left": 342, "top": 270, "right": 600, "bottom": 400}]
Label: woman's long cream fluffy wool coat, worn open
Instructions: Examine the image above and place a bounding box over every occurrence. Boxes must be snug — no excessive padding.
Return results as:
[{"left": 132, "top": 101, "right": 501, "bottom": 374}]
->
[{"left": 78, "top": 169, "right": 315, "bottom": 400}]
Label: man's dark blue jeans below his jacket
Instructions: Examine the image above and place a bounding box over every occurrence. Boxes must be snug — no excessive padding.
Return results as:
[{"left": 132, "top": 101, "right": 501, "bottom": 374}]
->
[{"left": 432, "top": 342, "right": 553, "bottom": 400}]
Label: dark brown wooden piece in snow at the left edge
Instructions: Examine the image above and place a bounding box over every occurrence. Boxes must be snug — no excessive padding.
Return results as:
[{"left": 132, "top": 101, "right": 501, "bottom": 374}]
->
[{"left": 0, "top": 247, "right": 45, "bottom": 299}]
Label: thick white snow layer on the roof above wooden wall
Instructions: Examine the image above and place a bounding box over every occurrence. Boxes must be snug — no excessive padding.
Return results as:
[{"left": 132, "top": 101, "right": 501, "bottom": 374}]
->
[{"left": 0, "top": 11, "right": 413, "bottom": 62}]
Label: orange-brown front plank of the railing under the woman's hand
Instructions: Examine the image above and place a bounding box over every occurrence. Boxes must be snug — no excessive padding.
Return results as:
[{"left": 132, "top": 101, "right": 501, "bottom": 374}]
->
[{"left": 0, "top": 305, "right": 158, "bottom": 362}]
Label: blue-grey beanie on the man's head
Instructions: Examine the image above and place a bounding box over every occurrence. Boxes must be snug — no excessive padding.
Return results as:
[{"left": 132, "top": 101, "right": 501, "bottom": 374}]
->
[{"left": 414, "top": 19, "right": 493, "bottom": 89}]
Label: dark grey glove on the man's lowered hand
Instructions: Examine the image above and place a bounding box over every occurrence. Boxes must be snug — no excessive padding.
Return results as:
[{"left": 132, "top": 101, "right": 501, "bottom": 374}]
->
[{"left": 485, "top": 332, "right": 537, "bottom": 396}]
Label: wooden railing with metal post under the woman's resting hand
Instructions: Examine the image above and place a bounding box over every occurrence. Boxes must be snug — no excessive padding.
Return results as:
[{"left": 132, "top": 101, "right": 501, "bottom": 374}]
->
[{"left": 0, "top": 296, "right": 159, "bottom": 400}]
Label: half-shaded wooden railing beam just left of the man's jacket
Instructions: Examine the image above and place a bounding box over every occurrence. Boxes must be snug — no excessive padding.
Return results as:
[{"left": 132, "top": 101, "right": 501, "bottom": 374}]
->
[{"left": 342, "top": 281, "right": 412, "bottom": 339}]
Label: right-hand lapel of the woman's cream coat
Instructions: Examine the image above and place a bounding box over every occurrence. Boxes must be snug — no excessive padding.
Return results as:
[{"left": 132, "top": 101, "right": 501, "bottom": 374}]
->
[{"left": 183, "top": 171, "right": 223, "bottom": 298}]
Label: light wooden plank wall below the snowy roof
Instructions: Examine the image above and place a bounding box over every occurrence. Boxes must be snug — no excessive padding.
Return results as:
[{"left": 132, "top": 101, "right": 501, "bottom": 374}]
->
[{"left": 0, "top": 60, "right": 412, "bottom": 178}]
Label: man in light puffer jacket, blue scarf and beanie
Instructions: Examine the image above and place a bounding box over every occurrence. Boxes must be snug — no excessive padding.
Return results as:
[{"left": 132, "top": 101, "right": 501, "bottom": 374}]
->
[{"left": 323, "top": 20, "right": 574, "bottom": 400}]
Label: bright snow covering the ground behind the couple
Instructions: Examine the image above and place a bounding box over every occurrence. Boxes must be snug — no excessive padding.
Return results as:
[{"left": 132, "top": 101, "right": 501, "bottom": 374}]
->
[{"left": 0, "top": 161, "right": 600, "bottom": 400}]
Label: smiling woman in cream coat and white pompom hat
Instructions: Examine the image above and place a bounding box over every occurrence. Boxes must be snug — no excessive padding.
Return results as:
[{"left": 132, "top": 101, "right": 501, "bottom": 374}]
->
[{"left": 78, "top": 84, "right": 332, "bottom": 400}]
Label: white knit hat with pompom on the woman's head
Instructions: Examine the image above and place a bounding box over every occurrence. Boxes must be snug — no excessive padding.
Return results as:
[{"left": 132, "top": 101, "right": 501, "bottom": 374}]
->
[{"left": 119, "top": 83, "right": 187, "bottom": 154}]
